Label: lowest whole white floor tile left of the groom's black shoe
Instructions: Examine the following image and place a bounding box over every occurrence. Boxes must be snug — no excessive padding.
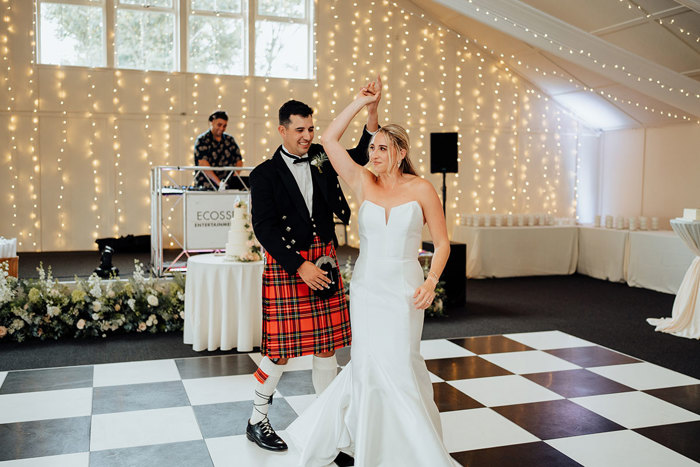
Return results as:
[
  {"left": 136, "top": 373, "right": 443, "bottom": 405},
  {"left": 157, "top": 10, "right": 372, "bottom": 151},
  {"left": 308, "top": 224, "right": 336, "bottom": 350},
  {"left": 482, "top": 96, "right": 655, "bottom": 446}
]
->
[{"left": 90, "top": 407, "right": 202, "bottom": 451}]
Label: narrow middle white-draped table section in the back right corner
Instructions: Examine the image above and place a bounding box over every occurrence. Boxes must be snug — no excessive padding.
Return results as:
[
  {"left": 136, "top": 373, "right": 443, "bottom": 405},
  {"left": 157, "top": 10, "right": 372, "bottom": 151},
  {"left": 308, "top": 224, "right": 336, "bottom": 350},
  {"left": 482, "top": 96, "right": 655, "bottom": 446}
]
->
[{"left": 576, "top": 226, "right": 629, "bottom": 282}]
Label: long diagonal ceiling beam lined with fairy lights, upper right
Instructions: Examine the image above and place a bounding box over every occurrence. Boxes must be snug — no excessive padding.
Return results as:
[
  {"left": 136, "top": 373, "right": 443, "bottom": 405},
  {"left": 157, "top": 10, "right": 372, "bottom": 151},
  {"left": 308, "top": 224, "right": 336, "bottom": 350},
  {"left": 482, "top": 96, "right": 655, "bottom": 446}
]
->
[{"left": 436, "top": 0, "right": 700, "bottom": 117}]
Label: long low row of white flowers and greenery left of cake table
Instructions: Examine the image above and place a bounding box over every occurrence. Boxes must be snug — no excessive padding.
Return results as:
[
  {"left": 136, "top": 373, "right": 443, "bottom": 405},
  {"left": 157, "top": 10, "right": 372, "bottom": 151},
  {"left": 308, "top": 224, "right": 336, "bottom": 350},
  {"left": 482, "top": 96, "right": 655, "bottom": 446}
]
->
[{"left": 0, "top": 261, "right": 185, "bottom": 342}]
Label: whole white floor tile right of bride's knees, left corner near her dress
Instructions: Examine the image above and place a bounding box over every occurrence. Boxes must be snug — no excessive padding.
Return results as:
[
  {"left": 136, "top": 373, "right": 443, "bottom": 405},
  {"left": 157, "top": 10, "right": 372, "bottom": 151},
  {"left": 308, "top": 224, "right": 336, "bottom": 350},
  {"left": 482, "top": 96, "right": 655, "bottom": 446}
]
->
[{"left": 448, "top": 375, "right": 563, "bottom": 407}]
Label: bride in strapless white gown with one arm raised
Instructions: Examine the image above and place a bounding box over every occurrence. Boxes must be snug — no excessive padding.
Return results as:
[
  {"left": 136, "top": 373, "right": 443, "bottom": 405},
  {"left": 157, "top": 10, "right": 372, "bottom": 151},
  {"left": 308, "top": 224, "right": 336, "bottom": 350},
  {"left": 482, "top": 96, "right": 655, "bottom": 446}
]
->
[{"left": 287, "top": 78, "right": 455, "bottom": 467}]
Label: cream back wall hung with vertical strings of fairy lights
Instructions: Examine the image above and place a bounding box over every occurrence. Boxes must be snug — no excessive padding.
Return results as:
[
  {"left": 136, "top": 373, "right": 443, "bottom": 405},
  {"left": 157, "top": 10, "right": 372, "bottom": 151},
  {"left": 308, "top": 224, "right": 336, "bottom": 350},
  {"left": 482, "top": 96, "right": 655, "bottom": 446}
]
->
[{"left": 0, "top": 0, "right": 598, "bottom": 251}]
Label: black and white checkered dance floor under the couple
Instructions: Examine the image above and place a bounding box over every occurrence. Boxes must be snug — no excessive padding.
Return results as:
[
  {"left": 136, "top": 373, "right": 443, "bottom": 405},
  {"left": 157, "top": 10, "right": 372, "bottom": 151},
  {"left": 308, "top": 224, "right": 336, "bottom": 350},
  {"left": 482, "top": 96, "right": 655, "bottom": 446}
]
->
[{"left": 0, "top": 331, "right": 700, "bottom": 467}]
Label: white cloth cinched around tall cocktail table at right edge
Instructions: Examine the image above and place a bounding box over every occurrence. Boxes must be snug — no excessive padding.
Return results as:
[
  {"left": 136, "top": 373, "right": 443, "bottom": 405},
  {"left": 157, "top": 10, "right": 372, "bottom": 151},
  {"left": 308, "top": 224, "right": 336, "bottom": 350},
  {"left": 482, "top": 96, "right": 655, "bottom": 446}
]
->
[{"left": 647, "top": 219, "right": 700, "bottom": 339}]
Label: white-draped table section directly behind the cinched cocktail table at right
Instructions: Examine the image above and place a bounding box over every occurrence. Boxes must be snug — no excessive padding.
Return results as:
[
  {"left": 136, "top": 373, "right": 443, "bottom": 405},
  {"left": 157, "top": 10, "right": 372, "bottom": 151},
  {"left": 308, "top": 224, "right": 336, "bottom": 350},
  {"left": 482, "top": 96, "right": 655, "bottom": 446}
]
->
[{"left": 627, "top": 230, "right": 695, "bottom": 294}]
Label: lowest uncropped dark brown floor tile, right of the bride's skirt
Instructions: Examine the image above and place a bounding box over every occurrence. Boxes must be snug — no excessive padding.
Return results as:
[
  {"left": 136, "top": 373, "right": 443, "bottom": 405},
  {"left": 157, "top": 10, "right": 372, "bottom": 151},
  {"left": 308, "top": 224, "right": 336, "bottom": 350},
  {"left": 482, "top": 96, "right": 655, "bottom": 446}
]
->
[{"left": 492, "top": 399, "right": 624, "bottom": 440}]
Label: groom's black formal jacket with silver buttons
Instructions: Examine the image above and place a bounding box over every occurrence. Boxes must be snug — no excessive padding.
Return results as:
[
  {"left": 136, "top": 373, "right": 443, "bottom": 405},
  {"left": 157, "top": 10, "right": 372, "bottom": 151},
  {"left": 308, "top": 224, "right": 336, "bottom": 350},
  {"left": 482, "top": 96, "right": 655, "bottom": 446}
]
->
[{"left": 250, "top": 127, "right": 372, "bottom": 275}]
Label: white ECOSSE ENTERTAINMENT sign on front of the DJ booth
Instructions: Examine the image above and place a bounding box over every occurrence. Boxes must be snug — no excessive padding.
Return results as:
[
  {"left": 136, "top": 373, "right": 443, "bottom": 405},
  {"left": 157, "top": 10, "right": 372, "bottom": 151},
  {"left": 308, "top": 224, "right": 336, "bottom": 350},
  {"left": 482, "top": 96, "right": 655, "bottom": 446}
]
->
[{"left": 183, "top": 190, "right": 250, "bottom": 250}]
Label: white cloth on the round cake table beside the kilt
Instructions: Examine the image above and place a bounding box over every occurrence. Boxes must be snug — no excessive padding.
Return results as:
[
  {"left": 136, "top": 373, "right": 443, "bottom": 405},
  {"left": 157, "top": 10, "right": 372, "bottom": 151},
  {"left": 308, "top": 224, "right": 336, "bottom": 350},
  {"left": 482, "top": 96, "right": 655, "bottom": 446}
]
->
[{"left": 184, "top": 254, "right": 263, "bottom": 352}]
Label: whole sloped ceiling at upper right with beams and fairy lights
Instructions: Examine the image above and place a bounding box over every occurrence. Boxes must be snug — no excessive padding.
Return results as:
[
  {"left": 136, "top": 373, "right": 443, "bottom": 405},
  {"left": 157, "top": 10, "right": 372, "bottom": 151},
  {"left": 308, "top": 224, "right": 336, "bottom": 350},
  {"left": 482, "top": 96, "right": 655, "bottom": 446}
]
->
[{"left": 412, "top": 0, "right": 700, "bottom": 130}]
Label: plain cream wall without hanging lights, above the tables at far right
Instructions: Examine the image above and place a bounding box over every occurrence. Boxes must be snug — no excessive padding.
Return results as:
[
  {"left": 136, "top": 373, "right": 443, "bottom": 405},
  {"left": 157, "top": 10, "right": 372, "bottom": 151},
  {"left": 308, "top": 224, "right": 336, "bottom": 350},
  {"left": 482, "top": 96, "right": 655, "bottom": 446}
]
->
[{"left": 599, "top": 124, "right": 700, "bottom": 229}]
